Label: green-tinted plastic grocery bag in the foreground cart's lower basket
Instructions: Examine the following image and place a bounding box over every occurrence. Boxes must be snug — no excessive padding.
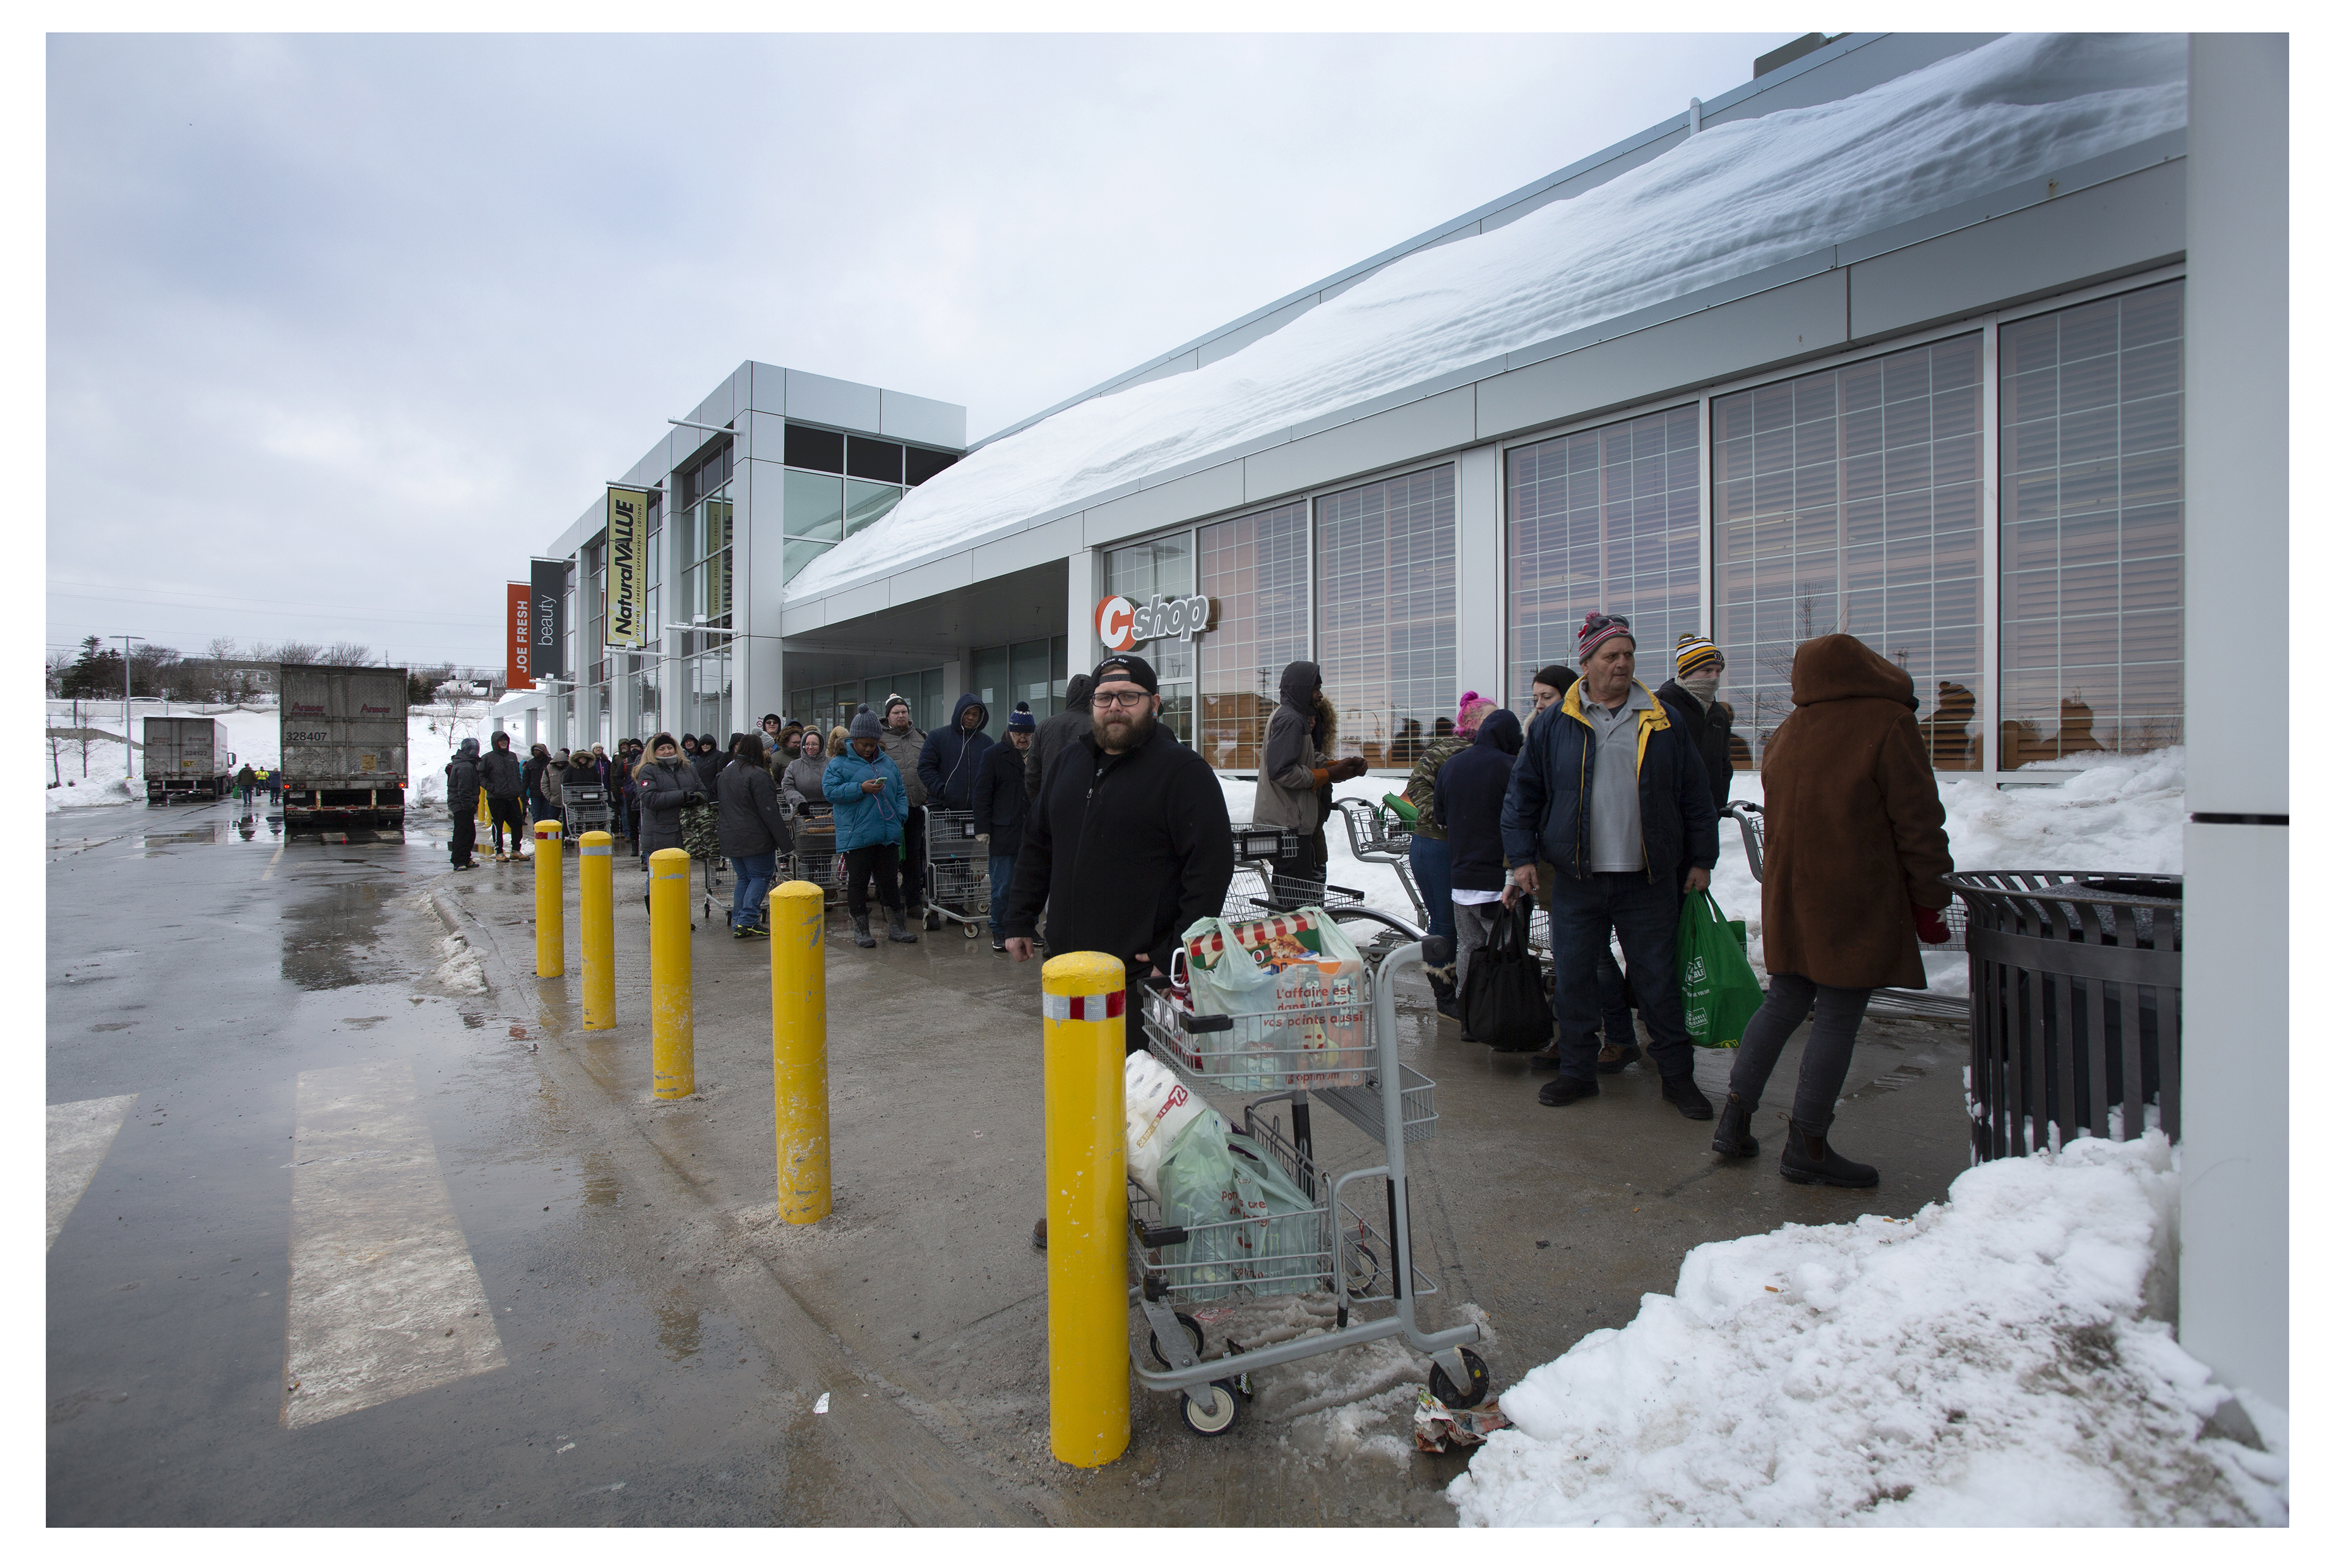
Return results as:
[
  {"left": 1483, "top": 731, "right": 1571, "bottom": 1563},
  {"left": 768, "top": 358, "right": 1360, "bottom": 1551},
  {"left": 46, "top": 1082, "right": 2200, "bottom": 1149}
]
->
[{"left": 1149, "top": 1110, "right": 1323, "bottom": 1284}]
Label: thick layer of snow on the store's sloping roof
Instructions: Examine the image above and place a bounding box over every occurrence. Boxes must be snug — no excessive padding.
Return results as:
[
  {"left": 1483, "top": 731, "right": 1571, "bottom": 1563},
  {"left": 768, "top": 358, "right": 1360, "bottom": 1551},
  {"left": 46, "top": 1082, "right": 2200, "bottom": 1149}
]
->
[{"left": 784, "top": 35, "right": 2188, "bottom": 602}]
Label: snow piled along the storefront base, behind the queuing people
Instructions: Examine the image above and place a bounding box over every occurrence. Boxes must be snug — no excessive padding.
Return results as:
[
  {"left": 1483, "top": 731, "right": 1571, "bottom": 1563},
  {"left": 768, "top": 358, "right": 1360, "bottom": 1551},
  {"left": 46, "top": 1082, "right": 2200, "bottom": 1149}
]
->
[{"left": 1221, "top": 747, "right": 2188, "bottom": 996}]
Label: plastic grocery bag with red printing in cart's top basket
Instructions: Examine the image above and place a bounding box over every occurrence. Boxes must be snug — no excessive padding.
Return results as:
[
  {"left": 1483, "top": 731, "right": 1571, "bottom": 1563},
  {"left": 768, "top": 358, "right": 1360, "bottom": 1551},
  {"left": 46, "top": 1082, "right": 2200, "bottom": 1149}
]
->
[{"left": 1186, "top": 905, "right": 1367, "bottom": 1089}]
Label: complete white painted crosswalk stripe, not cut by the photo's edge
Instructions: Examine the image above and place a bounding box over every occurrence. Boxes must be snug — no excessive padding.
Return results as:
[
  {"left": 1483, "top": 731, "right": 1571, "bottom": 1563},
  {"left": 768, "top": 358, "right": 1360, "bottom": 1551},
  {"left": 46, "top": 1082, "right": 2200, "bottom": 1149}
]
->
[{"left": 282, "top": 1063, "right": 507, "bottom": 1426}]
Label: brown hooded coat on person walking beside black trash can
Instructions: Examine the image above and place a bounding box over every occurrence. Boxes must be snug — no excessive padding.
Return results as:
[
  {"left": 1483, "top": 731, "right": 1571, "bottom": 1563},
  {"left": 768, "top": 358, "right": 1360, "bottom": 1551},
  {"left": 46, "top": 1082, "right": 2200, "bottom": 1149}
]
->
[{"left": 1760, "top": 633, "right": 1953, "bottom": 991}]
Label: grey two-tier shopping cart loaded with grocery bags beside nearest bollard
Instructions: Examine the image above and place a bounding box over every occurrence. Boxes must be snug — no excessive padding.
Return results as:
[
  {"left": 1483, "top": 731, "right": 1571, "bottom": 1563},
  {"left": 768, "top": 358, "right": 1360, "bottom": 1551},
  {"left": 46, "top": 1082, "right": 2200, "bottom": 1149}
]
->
[{"left": 1130, "top": 914, "right": 1488, "bottom": 1438}]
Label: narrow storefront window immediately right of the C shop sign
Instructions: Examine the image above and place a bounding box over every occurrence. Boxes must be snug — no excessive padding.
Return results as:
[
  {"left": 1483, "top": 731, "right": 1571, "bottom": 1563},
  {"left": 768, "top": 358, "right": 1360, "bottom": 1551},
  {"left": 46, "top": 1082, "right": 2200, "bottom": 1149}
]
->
[{"left": 1181, "top": 500, "right": 1309, "bottom": 768}]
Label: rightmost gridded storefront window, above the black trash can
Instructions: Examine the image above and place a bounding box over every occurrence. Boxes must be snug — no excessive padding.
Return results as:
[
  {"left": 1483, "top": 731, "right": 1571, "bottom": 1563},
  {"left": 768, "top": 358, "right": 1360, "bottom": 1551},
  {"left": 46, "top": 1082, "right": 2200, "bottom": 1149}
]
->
[{"left": 2002, "top": 282, "right": 2185, "bottom": 768}]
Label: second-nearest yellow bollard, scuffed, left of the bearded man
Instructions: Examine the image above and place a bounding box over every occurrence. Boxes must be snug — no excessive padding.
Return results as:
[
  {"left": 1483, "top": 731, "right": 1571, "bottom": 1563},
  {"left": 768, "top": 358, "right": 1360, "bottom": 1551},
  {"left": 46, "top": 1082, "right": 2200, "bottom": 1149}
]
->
[{"left": 767, "top": 882, "right": 832, "bottom": 1226}]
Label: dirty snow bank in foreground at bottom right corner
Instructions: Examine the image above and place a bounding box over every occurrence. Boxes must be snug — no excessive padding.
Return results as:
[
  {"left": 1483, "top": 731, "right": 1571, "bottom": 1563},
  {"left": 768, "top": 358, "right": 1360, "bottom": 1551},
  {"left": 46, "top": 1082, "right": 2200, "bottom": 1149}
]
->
[{"left": 1449, "top": 1133, "right": 2288, "bottom": 1526}]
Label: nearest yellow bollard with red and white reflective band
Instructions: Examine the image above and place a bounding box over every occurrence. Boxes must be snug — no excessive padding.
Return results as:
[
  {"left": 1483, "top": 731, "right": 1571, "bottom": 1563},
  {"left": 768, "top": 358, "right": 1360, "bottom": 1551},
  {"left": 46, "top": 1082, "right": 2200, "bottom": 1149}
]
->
[{"left": 1042, "top": 954, "right": 1130, "bottom": 1470}]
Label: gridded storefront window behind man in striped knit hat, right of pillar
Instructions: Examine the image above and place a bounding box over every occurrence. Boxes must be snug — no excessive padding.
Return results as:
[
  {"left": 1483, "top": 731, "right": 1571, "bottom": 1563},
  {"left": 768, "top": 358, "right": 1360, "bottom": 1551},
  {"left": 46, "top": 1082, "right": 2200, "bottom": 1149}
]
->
[{"left": 1507, "top": 405, "right": 1704, "bottom": 693}]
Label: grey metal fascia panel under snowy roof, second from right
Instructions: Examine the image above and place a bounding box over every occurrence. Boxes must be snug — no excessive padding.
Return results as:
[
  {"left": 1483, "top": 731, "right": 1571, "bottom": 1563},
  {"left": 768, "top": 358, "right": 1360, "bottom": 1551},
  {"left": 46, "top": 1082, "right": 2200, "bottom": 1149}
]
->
[{"left": 1476, "top": 272, "right": 1848, "bottom": 438}]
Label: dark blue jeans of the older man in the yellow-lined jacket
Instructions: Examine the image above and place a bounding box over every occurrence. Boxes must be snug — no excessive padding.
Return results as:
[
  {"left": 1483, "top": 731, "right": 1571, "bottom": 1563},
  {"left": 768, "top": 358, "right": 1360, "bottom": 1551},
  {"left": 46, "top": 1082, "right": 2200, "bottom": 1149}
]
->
[{"left": 1551, "top": 870, "right": 1695, "bottom": 1079}]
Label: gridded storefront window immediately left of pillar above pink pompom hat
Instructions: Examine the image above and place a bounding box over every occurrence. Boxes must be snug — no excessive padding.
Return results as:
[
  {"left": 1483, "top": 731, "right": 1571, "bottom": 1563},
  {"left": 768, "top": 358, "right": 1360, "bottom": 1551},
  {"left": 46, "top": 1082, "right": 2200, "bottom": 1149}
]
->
[{"left": 1316, "top": 463, "right": 1460, "bottom": 768}]
